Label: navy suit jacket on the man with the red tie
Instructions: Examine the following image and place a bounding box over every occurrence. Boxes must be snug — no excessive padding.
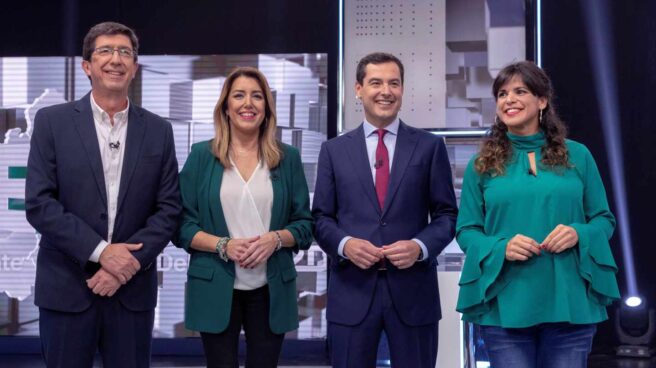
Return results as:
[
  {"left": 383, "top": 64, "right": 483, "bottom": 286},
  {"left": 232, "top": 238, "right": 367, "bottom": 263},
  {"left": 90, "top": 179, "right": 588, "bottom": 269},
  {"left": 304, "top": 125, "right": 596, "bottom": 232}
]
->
[{"left": 312, "top": 122, "right": 457, "bottom": 326}]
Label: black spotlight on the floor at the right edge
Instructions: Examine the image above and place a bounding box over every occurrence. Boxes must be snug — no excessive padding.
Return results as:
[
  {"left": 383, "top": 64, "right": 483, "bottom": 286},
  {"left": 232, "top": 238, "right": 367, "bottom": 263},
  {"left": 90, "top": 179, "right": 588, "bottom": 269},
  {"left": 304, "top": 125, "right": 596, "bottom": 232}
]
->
[{"left": 615, "top": 296, "right": 656, "bottom": 358}]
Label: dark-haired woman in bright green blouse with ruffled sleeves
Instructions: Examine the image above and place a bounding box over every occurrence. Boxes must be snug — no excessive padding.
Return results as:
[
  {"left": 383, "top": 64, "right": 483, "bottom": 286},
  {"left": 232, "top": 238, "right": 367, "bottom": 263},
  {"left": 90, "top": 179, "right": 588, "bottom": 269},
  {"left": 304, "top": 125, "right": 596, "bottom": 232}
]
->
[{"left": 456, "top": 62, "right": 619, "bottom": 368}]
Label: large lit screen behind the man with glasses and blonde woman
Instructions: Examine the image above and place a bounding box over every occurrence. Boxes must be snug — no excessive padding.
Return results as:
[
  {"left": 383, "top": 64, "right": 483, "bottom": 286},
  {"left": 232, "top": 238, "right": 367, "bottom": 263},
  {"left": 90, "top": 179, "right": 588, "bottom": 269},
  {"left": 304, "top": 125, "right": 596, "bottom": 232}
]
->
[{"left": 0, "top": 54, "right": 328, "bottom": 339}]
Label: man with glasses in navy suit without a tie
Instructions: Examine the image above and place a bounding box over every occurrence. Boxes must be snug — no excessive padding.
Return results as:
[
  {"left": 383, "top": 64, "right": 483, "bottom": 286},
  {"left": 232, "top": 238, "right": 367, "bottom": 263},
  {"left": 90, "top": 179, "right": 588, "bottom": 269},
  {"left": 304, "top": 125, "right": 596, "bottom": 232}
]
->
[{"left": 25, "top": 22, "right": 182, "bottom": 368}]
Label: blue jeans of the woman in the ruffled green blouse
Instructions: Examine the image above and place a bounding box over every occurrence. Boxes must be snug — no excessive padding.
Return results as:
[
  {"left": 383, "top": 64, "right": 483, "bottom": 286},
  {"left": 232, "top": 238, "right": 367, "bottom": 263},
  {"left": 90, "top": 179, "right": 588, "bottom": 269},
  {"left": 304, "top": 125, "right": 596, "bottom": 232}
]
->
[{"left": 480, "top": 323, "right": 597, "bottom": 368}]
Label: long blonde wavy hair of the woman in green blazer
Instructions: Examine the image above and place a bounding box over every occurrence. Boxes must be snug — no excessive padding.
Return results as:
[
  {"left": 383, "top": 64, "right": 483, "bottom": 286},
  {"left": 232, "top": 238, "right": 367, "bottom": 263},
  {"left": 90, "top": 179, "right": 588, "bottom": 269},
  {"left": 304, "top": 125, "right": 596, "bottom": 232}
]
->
[{"left": 212, "top": 67, "right": 283, "bottom": 169}]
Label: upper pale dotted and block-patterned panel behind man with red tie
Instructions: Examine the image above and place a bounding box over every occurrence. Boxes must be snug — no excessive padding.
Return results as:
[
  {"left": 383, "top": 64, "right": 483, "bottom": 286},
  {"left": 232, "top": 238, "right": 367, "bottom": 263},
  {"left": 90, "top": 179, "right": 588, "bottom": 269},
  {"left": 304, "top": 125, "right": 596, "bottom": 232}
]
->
[{"left": 343, "top": 0, "right": 526, "bottom": 130}]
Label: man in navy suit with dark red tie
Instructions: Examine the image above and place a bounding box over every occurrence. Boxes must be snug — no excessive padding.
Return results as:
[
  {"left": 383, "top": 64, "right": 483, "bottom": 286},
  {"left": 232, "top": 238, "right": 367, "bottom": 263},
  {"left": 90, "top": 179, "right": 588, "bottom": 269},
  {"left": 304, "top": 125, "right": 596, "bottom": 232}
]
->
[{"left": 312, "top": 53, "right": 457, "bottom": 368}]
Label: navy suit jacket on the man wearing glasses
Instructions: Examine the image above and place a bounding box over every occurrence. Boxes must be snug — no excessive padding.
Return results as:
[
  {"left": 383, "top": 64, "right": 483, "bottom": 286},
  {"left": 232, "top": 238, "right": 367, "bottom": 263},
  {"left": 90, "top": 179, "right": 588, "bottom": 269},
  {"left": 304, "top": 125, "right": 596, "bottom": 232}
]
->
[{"left": 25, "top": 94, "right": 182, "bottom": 312}]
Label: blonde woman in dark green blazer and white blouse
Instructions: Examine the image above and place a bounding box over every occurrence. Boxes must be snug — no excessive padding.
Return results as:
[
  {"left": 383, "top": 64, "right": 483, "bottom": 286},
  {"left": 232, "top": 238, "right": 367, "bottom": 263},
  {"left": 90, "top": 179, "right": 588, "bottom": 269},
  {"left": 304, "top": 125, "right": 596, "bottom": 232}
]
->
[{"left": 175, "top": 67, "right": 313, "bottom": 367}]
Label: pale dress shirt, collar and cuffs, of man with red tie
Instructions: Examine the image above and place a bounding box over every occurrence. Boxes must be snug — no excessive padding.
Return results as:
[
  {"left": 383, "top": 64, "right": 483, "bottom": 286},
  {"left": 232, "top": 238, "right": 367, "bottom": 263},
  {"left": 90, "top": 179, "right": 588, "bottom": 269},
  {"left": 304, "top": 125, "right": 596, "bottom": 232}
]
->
[{"left": 337, "top": 118, "right": 428, "bottom": 261}]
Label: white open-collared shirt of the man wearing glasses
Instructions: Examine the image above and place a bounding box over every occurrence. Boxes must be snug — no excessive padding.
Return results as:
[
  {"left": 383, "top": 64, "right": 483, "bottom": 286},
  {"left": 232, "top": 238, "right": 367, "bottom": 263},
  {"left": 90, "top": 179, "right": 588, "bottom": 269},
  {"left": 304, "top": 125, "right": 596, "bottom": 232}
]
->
[{"left": 89, "top": 93, "right": 130, "bottom": 262}]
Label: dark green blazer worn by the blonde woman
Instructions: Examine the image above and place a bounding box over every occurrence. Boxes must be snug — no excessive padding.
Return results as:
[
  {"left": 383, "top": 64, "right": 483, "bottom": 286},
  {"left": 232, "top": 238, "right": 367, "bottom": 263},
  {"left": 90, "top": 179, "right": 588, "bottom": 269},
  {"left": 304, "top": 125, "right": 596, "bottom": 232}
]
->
[{"left": 174, "top": 141, "right": 313, "bottom": 334}]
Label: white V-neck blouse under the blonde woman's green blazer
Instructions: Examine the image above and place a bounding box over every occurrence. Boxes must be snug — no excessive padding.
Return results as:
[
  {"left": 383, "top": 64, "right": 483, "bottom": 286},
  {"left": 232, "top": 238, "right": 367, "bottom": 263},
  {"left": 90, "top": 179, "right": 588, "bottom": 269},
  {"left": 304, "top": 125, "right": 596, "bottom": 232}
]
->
[{"left": 220, "top": 159, "right": 273, "bottom": 290}]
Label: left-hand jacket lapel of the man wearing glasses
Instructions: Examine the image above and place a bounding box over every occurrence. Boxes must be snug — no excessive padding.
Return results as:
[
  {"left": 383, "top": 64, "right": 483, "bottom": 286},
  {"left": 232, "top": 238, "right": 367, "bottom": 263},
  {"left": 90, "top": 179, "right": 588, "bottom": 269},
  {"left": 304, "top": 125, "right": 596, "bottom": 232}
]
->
[{"left": 73, "top": 94, "right": 107, "bottom": 208}]
